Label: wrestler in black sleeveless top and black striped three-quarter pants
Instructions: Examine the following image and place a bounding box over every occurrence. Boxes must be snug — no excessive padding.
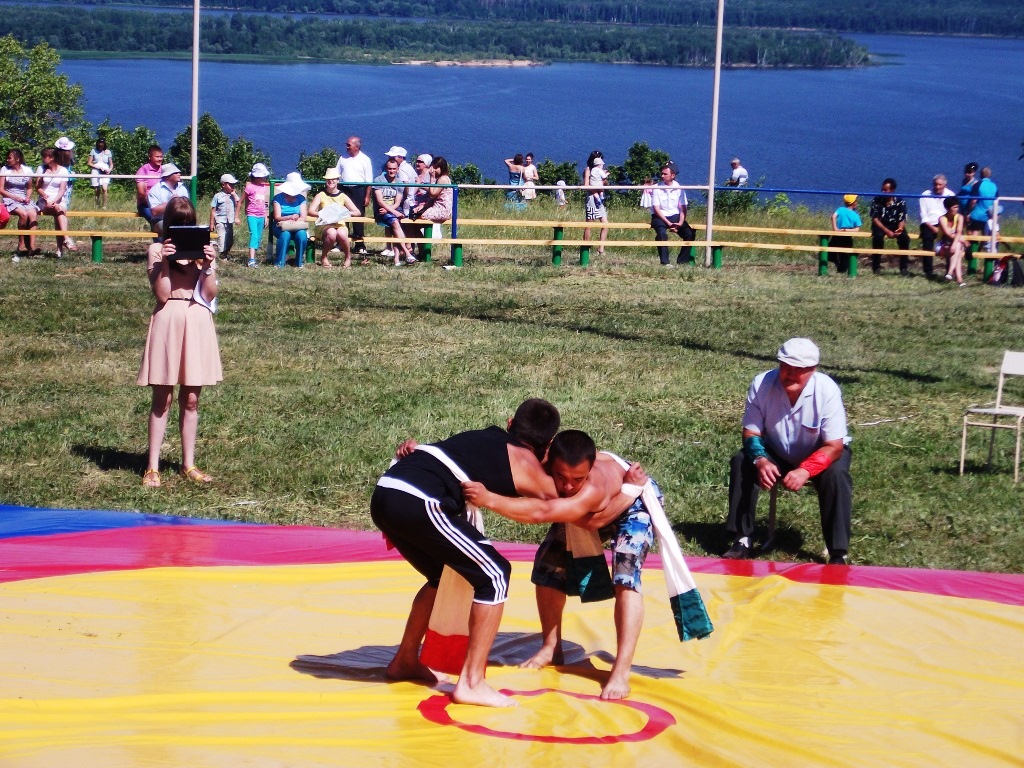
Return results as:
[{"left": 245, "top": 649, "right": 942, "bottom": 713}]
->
[{"left": 370, "top": 398, "right": 559, "bottom": 707}]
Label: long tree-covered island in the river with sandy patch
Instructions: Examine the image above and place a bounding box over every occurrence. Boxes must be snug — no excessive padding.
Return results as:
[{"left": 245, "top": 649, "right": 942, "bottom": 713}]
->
[{"left": 4, "top": 6, "right": 867, "bottom": 68}]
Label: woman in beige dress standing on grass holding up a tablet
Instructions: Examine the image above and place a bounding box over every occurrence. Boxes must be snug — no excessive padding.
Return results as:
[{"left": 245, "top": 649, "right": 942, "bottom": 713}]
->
[{"left": 136, "top": 198, "right": 223, "bottom": 487}]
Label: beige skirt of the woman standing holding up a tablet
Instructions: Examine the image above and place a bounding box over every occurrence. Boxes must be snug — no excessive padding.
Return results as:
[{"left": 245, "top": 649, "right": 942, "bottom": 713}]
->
[{"left": 136, "top": 299, "right": 224, "bottom": 387}]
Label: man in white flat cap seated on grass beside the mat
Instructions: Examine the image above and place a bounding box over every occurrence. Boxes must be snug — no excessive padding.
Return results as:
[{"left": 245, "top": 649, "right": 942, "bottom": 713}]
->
[{"left": 725, "top": 338, "right": 853, "bottom": 565}]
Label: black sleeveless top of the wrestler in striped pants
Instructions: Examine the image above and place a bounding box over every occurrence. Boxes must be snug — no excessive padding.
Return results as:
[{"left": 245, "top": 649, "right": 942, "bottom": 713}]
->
[{"left": 384, "top": 427, "right": 519, "bottom": 512}]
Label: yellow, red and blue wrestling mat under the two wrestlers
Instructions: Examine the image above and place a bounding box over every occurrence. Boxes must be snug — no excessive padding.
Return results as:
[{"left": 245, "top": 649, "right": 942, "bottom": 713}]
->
[{"left": 0, "top": 506, "right": 1024, "bottom": 768}]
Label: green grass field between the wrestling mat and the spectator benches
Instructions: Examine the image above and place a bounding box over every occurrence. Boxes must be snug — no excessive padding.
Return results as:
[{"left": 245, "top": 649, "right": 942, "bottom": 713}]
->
[{"left": 0, "top": 195, "right": 1024, "bottom": 571}]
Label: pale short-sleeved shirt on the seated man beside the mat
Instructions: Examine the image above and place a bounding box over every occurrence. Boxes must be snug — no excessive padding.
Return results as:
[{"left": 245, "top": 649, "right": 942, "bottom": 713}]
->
[{"left": 743, "top": 369, "right": 850, "bottom": 465}]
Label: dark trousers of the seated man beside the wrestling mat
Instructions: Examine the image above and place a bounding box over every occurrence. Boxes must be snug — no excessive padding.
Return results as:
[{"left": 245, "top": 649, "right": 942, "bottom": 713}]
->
[{"left": 725, "top": 446, "right": 853, "bottom": 554}]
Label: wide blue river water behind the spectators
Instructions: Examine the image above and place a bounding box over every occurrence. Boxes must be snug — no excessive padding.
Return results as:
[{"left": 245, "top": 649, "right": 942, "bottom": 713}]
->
[{"left": 54, "top": 36, "right": 1024, "bottom": 206}]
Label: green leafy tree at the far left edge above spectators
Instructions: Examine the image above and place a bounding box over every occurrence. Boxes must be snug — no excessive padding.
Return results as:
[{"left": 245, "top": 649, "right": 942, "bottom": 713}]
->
[{"left": 0, "top": 34, "right": 85, "bottom": 155}]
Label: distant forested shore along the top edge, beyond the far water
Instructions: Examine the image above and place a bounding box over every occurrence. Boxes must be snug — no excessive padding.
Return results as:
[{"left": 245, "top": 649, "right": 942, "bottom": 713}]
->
[{"left": 68, "top": 0, "right": 1024, "bottom": 37}]
